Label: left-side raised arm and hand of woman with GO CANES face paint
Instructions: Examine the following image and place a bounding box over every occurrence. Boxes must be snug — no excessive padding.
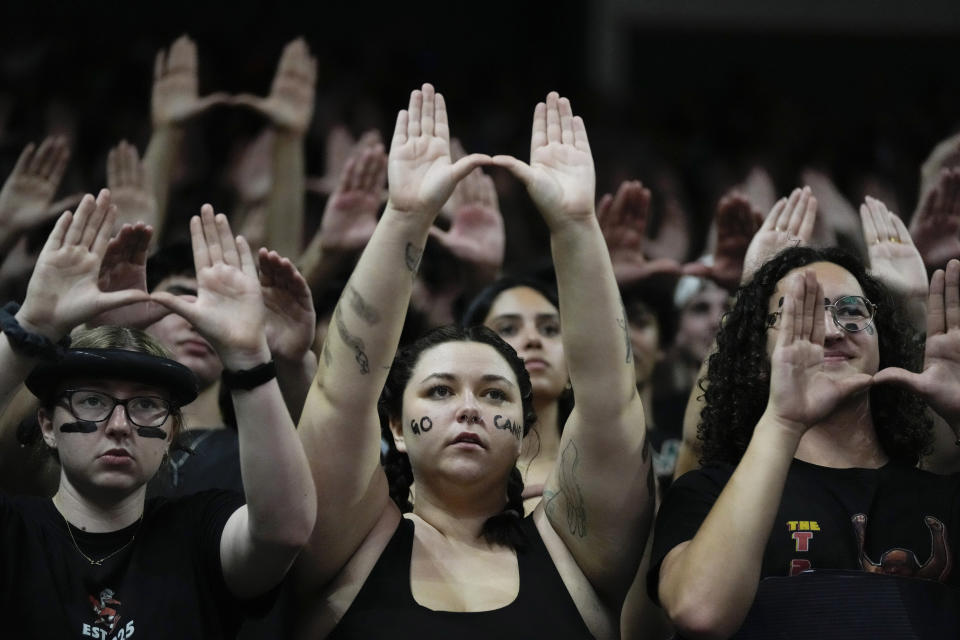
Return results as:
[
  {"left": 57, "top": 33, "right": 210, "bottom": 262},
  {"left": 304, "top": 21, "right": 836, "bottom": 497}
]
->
[{"left": 298, "top": 84, "right": 489, "bottom": 588}]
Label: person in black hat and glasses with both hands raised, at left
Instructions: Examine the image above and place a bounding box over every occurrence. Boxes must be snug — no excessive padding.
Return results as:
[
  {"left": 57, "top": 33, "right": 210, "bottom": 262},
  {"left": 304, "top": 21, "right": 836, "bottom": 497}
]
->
[{"left": 0, "top": 190, "right": 316, "bottom": 640}]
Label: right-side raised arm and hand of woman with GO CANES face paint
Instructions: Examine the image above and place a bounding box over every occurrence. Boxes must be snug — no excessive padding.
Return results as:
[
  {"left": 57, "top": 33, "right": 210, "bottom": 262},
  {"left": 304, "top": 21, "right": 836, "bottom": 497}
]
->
[{"left": 494, "top": 93, "right": 654, "bottom": 610}]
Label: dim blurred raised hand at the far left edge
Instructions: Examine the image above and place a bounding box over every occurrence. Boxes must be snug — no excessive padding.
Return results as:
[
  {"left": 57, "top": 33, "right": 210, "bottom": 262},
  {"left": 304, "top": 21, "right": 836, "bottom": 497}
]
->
[{"left": 0, "top": 137, "right": 70, "bottom": 250}]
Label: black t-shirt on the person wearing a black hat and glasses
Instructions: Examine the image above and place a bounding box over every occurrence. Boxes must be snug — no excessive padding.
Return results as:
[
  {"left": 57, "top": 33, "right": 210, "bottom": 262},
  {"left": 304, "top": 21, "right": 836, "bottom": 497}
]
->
[{"left": 0, "top": 491, "right": 255, "bottom": 640}]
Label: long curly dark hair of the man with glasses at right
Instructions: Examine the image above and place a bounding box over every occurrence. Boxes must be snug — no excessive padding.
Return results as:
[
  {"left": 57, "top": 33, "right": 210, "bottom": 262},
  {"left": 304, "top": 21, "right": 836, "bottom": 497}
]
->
[{"left": 698, "top": 247, "right": 932, "bottom": 466}]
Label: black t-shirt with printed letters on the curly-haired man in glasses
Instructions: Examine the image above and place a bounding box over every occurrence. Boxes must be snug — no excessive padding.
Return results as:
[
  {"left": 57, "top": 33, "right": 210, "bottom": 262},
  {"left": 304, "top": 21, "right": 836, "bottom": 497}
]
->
[{"left": 647, "top": 460, "right": 960, "bottom": 601}]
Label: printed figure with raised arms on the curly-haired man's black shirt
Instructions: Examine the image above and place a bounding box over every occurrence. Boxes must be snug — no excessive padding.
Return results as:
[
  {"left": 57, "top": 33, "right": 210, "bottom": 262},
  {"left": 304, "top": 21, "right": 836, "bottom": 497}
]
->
[{"left": 850, "top": 513, "right": 953, "bottom": 582}]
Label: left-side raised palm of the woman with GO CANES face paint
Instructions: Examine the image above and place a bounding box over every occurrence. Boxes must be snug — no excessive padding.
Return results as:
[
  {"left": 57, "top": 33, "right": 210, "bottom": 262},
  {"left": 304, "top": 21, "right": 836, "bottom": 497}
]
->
[{"left": 387, "top": 84, "right": 490, "bottom": 222}]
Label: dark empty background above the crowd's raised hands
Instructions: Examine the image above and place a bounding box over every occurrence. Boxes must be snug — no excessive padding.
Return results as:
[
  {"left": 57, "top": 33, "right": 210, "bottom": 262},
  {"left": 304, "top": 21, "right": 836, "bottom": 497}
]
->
[{"left": 0, "top": 0, "right": 960, "bottom": 264}]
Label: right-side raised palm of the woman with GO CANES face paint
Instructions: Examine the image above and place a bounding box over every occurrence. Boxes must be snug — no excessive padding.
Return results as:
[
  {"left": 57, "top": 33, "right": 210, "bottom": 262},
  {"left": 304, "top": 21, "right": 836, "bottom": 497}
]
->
[{"left": 493, "top": 91, "right": 596, "bottom": 231}]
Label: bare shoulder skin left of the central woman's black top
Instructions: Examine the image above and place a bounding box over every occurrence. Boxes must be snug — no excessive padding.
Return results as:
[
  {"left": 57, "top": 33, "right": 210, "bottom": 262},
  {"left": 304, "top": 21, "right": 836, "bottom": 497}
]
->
[{"left": 295, "top": 502, "right": 402, "bottom": 639}]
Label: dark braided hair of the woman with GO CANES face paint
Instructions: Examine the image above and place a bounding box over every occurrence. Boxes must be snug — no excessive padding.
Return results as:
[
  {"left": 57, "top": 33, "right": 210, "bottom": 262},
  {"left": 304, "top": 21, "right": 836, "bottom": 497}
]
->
[{"left": 377, "top": 325, "right": 537, "bottom": 549}]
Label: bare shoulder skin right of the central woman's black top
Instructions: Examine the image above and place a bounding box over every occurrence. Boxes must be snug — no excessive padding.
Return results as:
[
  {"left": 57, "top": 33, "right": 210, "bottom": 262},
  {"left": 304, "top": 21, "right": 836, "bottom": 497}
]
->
[{"left": 533, "top": 503, "right": 619, "bottom": 638}]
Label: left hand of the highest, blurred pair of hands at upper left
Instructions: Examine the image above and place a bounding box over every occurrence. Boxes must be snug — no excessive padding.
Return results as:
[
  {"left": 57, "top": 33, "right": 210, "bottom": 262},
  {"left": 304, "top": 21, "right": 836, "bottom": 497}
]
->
[{"left": 150, "top": 36, "right": 229, "bottom": 128}]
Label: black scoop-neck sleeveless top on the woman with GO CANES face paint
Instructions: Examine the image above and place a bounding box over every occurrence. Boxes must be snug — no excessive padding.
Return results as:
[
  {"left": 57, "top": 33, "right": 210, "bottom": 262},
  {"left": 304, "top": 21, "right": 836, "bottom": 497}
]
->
[{"left": 328, "top": 516, "right": 592, "bottom": 640}]
